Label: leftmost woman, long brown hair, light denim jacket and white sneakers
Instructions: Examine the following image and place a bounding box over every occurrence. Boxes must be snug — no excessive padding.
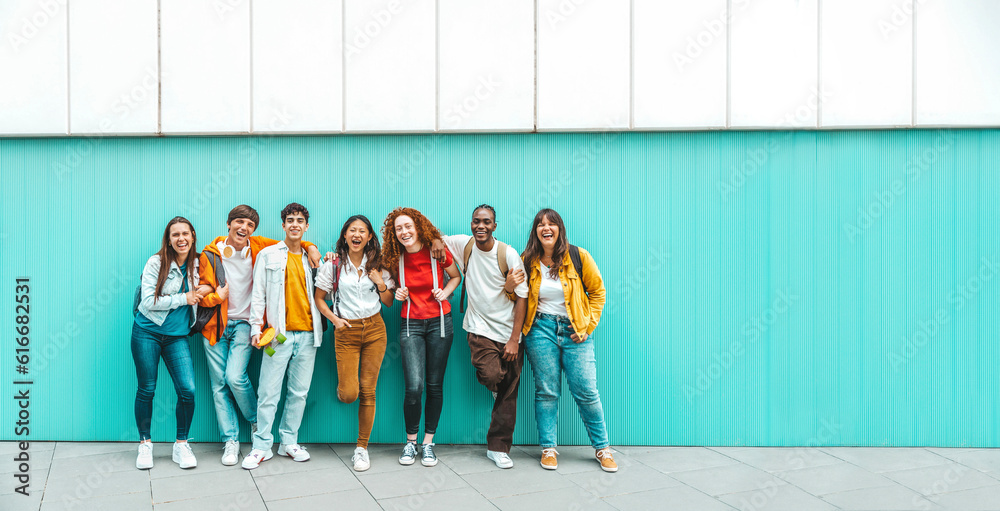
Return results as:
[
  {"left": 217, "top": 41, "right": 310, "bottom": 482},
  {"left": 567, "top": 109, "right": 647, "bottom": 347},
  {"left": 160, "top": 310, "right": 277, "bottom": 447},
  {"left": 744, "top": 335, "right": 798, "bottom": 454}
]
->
[{"left": 132, "top": 216, "right": 209, "bottom": 469}]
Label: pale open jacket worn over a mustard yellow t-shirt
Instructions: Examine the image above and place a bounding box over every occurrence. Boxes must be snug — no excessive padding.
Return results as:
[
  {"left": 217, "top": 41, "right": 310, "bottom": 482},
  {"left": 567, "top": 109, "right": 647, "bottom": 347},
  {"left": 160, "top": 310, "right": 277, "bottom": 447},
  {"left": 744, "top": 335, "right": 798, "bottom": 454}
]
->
[{"left": 250, "top": 241, "right": 323, "bottom": 348}]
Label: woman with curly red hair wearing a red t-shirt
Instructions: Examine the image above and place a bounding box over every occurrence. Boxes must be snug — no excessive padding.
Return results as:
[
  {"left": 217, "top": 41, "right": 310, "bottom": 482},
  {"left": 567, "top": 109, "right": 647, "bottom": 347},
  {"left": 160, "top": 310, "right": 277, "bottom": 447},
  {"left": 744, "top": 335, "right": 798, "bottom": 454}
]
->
[{"left": 382, "top": 208, "right": 462, "bottom": 467}]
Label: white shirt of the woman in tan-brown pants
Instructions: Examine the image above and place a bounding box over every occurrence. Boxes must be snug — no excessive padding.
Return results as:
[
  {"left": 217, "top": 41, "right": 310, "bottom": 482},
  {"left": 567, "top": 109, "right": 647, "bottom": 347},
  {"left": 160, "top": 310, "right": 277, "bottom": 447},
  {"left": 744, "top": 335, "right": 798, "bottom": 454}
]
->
[{"left": 316, "top": 256, "right": 395, "bottom": 319}]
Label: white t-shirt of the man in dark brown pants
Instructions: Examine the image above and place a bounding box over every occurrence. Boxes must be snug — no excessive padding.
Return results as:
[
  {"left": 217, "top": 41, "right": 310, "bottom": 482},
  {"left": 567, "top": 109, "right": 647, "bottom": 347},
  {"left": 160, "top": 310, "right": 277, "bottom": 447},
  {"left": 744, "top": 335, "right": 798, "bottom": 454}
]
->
[{"left": 444, "top": 234, "right": 528, "bottom": 343}]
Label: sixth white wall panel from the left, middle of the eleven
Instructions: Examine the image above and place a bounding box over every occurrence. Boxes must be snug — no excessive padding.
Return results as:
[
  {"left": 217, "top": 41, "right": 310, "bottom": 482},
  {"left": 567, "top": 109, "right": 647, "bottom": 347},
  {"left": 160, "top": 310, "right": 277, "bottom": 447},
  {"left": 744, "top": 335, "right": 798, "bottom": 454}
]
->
[{"left": 438, "top": 0, "right": 535, "bottom": 131}]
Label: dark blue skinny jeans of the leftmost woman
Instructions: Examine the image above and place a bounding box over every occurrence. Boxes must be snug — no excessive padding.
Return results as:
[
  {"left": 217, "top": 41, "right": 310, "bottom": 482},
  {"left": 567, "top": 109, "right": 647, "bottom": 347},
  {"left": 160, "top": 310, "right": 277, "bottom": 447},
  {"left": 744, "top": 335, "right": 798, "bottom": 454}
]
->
[{"left": 132, "top": 323, "right": 194, "bottom": 441}]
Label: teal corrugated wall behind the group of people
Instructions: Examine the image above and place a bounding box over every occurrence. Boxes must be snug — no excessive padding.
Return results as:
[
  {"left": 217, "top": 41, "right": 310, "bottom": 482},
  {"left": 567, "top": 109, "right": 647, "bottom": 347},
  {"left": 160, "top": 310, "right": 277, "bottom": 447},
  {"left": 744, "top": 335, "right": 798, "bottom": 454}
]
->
[{"left": 0, "top": 130, "right": 1000, "bottom": 447}]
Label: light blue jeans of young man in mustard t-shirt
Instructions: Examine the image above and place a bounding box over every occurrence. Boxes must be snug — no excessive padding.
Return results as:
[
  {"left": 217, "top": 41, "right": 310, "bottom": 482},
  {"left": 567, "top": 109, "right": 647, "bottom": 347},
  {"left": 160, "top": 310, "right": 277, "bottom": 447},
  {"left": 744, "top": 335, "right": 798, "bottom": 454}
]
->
[{"left": 253, "top": 331, "right": 316, "bottom": 451}]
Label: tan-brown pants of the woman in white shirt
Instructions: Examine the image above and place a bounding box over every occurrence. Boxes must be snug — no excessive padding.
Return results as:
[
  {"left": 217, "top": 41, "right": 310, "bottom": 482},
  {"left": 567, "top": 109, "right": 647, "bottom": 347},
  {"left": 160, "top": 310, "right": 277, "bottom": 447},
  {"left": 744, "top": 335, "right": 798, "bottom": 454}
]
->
[{"left": 333, "top": 314, "right": 386, "bottom": 449}]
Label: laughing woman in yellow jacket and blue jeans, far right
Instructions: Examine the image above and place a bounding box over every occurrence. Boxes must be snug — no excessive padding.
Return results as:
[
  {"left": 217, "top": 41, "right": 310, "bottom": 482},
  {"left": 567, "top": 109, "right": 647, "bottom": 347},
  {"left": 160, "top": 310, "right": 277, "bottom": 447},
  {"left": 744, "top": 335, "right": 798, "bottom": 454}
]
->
[{"left": 521, "top": 209, "right": 618, "bottom": 472}]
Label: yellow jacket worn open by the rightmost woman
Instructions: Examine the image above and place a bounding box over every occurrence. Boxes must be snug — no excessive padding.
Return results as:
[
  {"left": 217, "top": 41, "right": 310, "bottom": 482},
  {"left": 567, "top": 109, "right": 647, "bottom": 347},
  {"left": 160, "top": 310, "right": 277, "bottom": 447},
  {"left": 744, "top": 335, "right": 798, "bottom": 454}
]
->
[{"left": 521, "top": 248, "right": 605, "bottom": 335}]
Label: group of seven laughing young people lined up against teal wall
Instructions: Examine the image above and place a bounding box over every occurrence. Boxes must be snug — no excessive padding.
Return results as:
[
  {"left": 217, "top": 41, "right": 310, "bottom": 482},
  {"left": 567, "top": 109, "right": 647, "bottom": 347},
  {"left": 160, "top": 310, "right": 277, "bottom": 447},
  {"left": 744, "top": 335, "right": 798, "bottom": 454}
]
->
[{"left": 131, "top": 203, "right": 618, "bottom": 472}]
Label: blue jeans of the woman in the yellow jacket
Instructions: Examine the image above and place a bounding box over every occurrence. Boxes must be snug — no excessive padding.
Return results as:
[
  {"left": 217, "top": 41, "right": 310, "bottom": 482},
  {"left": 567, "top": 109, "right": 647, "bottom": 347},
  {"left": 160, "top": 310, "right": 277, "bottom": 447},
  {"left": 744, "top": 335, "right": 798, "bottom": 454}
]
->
[{"left": 524, "top": 313, "right": 608, "bottom": 449}]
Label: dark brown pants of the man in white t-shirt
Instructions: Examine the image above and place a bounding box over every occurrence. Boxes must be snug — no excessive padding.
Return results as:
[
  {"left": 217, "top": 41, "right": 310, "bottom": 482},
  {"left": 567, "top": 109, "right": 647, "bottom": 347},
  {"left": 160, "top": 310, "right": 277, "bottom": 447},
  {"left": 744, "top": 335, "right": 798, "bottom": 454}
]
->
[{"left": 468, "top": 334, "right": 524, "bottom": 453}]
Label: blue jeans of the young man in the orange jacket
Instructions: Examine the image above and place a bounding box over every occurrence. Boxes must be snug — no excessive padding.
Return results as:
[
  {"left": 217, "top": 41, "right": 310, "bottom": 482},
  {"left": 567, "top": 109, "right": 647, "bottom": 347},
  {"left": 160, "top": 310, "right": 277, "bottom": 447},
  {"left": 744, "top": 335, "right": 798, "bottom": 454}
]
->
[{"left": 202, "top": 319, "right": 257, "bottom": 442}]
